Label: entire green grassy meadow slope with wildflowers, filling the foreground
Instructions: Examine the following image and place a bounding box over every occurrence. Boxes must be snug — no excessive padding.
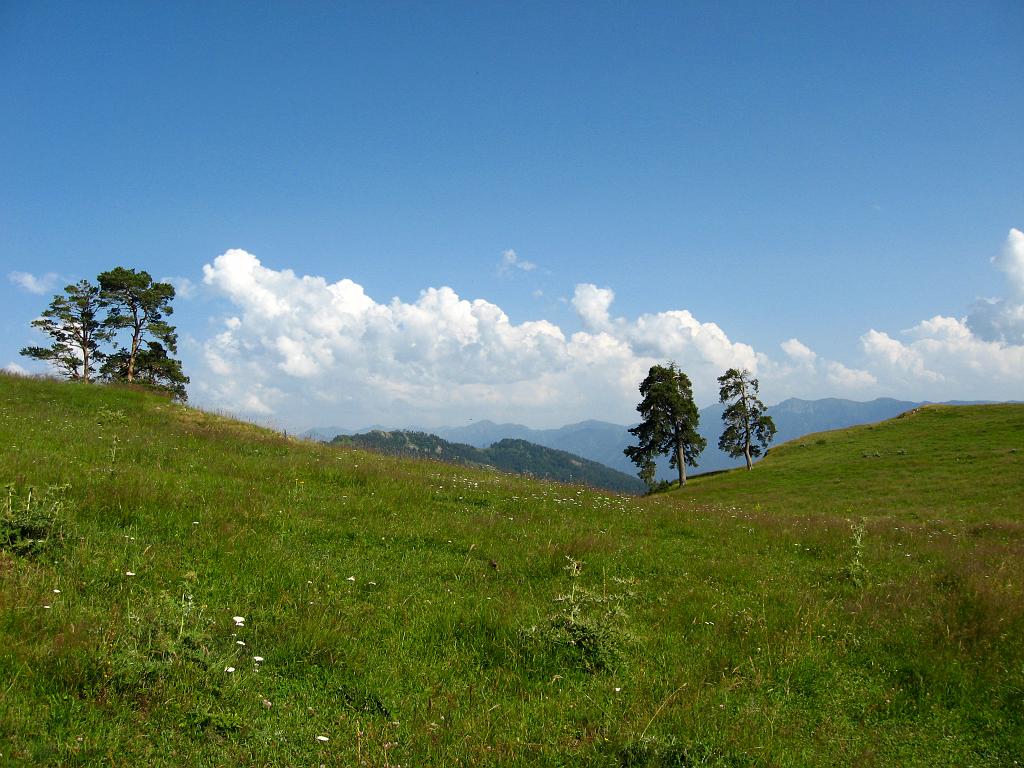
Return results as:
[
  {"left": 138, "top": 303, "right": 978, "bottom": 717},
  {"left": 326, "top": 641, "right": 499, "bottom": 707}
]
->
[{"left": 0, "top": 377, "right": 1024, "bottom": 766}]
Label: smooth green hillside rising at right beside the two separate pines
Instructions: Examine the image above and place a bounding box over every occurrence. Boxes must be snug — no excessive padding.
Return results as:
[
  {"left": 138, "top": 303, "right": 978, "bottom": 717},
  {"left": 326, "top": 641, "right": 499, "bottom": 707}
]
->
[{"left": 677, "top": 404, "right": 1024, "bottom": 522}]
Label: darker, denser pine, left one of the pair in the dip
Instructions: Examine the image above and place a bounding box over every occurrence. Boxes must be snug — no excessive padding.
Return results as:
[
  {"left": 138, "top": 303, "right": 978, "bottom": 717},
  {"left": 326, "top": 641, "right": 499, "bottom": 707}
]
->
[{"left": 623, "top": 362, "right": 708, "bottom": 485}]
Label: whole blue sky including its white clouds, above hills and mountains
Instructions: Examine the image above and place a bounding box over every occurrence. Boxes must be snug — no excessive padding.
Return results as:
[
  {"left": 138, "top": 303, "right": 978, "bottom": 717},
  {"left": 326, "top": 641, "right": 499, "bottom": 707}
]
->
[{"left": 0, "top": 2, "right": 1024, "bottom": 428}]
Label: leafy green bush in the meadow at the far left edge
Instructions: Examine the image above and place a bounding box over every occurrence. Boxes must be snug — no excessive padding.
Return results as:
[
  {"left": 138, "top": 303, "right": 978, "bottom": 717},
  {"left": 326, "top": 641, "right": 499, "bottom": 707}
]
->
[{"left": 0, "top": 483, "right": 68, "bottom": 557}]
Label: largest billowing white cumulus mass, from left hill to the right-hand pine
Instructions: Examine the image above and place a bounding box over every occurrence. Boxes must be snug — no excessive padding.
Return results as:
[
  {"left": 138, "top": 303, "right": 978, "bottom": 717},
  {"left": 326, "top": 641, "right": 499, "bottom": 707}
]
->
[{"left": 196, "top": 249, "right": 757, "bottom": 423}]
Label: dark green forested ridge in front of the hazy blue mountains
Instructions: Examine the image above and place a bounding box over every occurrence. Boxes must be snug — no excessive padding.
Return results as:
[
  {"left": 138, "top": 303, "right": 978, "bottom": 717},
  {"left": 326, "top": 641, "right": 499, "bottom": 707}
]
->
[{"left": 331, "top": 429, "right": 646, "bottom": 494}]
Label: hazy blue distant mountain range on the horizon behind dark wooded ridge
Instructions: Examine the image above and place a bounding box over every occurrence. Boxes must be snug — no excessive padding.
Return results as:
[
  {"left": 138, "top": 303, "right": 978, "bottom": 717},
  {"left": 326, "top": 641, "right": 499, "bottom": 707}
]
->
[{"left": 303, "top": 397, "right": 995, "bottom": 479}]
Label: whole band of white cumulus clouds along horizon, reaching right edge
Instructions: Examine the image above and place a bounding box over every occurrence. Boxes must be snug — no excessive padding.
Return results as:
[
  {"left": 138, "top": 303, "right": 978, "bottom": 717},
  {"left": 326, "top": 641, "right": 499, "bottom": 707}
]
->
[{"left": 193, "top": 229, "right": 1024, "bottom": 427}]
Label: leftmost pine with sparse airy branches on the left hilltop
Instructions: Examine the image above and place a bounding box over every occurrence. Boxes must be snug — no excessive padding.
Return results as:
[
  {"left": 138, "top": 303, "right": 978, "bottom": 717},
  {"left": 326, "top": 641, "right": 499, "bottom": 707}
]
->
[{"left": 20, "top": 280, "right": 111, "bottom": 382}]
